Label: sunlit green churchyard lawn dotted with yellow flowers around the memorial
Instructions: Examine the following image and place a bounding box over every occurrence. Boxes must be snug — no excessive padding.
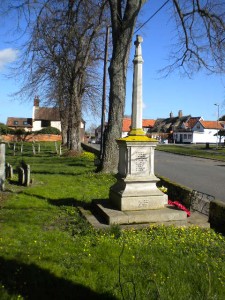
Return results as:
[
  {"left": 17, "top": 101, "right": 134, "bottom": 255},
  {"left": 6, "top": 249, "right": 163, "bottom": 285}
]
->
[{"left": 0, "top": 144, "right": 225, "bottom": 300}]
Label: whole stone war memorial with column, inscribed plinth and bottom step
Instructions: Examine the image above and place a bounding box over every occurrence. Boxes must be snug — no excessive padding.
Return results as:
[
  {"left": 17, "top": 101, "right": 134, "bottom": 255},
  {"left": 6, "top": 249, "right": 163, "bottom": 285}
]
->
[{"left": 96, "top": 36, "right": 187, "bottom": 225}]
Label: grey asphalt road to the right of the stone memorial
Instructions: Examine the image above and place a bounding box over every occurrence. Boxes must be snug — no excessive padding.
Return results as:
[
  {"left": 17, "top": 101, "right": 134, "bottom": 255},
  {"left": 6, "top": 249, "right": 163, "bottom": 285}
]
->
[{"left": 155, "top": 151, "right": 225, "bottom": 201}]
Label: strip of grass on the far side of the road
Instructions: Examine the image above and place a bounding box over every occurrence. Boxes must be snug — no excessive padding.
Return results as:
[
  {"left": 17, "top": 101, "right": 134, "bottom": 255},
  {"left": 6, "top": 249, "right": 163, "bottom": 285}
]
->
[{"left": 156, "top": 144, "right": 225, "bottom": 161}]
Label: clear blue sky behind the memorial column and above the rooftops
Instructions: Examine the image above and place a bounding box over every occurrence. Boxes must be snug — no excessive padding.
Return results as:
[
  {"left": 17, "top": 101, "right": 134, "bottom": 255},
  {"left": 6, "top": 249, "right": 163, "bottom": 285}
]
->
[{"left": 0, "top": 0, "right": 225, "bottom": 126}]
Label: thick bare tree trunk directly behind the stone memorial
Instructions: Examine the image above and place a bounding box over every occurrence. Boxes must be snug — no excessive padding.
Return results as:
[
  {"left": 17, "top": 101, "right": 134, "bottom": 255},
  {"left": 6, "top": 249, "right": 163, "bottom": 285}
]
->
[{"left": 101, "top": 0, "right": 144, "bottom": 173}]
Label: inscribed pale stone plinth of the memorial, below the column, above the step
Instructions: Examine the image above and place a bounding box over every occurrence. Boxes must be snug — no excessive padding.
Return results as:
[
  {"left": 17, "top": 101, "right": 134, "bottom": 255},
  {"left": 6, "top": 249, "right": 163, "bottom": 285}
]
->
[{"left": 109, "top": 136, "right": 168, "bottom": 211}]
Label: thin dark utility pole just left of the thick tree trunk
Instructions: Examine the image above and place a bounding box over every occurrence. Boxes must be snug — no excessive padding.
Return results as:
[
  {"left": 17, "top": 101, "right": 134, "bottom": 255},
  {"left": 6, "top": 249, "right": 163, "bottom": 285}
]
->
[{"left": 100, "top": 26, "right": 110, "bottom": 159}]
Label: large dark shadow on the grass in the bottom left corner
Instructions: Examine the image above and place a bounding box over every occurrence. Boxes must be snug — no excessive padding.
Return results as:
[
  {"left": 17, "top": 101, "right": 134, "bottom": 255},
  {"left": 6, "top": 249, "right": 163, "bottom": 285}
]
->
[{"left": 0, "top": 257, "right": 115, "bottom": 300}]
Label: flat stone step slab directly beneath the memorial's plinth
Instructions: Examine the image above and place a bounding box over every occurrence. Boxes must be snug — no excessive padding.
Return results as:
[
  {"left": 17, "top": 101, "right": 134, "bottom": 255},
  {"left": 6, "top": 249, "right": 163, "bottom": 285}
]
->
[{"left": 94, "top": 201, "right": 187, "bottom": 225}]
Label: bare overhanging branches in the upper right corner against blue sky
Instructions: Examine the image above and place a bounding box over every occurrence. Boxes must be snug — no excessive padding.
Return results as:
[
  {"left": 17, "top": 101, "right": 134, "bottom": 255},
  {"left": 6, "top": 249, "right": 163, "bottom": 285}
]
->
[{"left": 168, "top": 0, "right": 225, "bottom": 75}]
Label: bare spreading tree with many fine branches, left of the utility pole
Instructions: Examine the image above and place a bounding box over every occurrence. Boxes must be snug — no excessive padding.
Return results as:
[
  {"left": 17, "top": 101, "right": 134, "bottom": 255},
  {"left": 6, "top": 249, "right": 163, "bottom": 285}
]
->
[{"left": 0, "top": 0, "right": 106, "bottom": 151}]
